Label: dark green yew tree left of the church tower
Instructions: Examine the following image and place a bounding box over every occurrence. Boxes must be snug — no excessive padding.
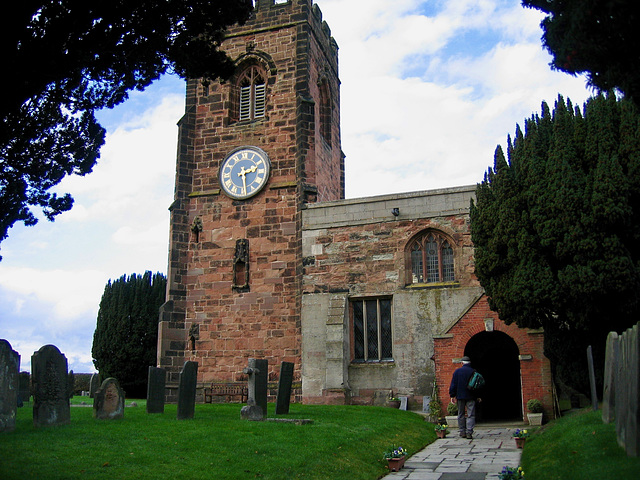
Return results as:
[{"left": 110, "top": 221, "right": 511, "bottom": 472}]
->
[{"left": 91, "top": 271, "right": 167, "bottom": 398}]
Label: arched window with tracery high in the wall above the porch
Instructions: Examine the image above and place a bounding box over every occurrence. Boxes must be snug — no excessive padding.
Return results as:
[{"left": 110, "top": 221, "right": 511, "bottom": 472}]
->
[{"left": 408, "top": 231, "right": 455, "bottom": 283}]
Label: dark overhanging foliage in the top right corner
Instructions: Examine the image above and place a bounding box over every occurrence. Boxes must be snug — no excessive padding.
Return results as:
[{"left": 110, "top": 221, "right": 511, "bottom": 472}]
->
[{"left": 522, "top": 0, "right": 640, "bottom": 105}]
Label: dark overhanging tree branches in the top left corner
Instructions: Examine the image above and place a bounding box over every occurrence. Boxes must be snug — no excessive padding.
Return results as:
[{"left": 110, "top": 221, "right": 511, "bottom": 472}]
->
[{"left": 0, "top": 0, "right": 253, "bottom": 258}]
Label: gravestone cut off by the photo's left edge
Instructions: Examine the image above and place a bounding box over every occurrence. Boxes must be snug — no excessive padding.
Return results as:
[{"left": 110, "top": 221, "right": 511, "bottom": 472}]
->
[{"left": 0, "top": 339, "right": 20, "bottom": 432}]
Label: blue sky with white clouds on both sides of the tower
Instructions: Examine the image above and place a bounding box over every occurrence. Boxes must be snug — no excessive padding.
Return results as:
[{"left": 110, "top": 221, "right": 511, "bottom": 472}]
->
[{"left": 0, "top": 0, "right": 591, "bottom": 372}]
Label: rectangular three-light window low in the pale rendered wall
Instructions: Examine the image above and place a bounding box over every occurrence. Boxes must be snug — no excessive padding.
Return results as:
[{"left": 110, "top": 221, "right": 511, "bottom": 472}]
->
[{"left": 350, "top": 298, "right": 393, "bottom": 362}]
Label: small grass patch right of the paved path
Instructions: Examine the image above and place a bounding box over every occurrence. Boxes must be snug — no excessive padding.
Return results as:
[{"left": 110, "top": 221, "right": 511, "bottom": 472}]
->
[{"left": 521, "top": 410, "right": 640, "bottom": 480}]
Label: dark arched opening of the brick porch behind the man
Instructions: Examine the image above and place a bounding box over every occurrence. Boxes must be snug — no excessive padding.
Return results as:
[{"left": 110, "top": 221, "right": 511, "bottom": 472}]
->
[{"left": 464, "top": 331, "right": 522, "bottom": 421}]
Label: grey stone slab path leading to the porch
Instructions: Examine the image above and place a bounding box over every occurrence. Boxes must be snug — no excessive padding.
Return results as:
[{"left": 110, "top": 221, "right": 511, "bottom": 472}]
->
[{"left": 383, "top": 427, "right": 522, "bottom": 480}]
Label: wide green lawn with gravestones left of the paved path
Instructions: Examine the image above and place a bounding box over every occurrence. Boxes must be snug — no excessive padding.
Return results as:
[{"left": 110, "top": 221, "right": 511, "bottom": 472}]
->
[{"left": 0, "top": 397, "right": 435, "bottom": 480}]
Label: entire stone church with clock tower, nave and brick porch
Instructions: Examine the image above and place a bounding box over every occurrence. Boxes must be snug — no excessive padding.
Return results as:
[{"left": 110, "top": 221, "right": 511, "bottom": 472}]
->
[{"left": 158, "top": 0, "right": 553, "bottom": 420}]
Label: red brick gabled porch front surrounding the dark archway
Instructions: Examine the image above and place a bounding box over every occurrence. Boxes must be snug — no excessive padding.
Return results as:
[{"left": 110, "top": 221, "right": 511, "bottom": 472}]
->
[{"left": 433, "top": 294, "right": 553, "bottom": 418}]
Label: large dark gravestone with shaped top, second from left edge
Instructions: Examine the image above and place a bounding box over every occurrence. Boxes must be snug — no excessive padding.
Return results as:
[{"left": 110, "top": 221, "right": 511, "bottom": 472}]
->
[{"left": 31, "top": 345, "right": 71, "bottom": 427}]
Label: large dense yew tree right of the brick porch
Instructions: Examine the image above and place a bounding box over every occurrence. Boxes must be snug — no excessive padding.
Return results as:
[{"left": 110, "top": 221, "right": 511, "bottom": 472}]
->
[{"left": 471, "top": 94, "right": 640, "bottom": 392}]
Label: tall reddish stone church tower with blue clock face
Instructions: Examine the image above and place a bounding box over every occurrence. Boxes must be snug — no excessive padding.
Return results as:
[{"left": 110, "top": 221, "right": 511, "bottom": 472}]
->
[{"left": 158, "top": 0, "right": 344, "bottom": 400}]
